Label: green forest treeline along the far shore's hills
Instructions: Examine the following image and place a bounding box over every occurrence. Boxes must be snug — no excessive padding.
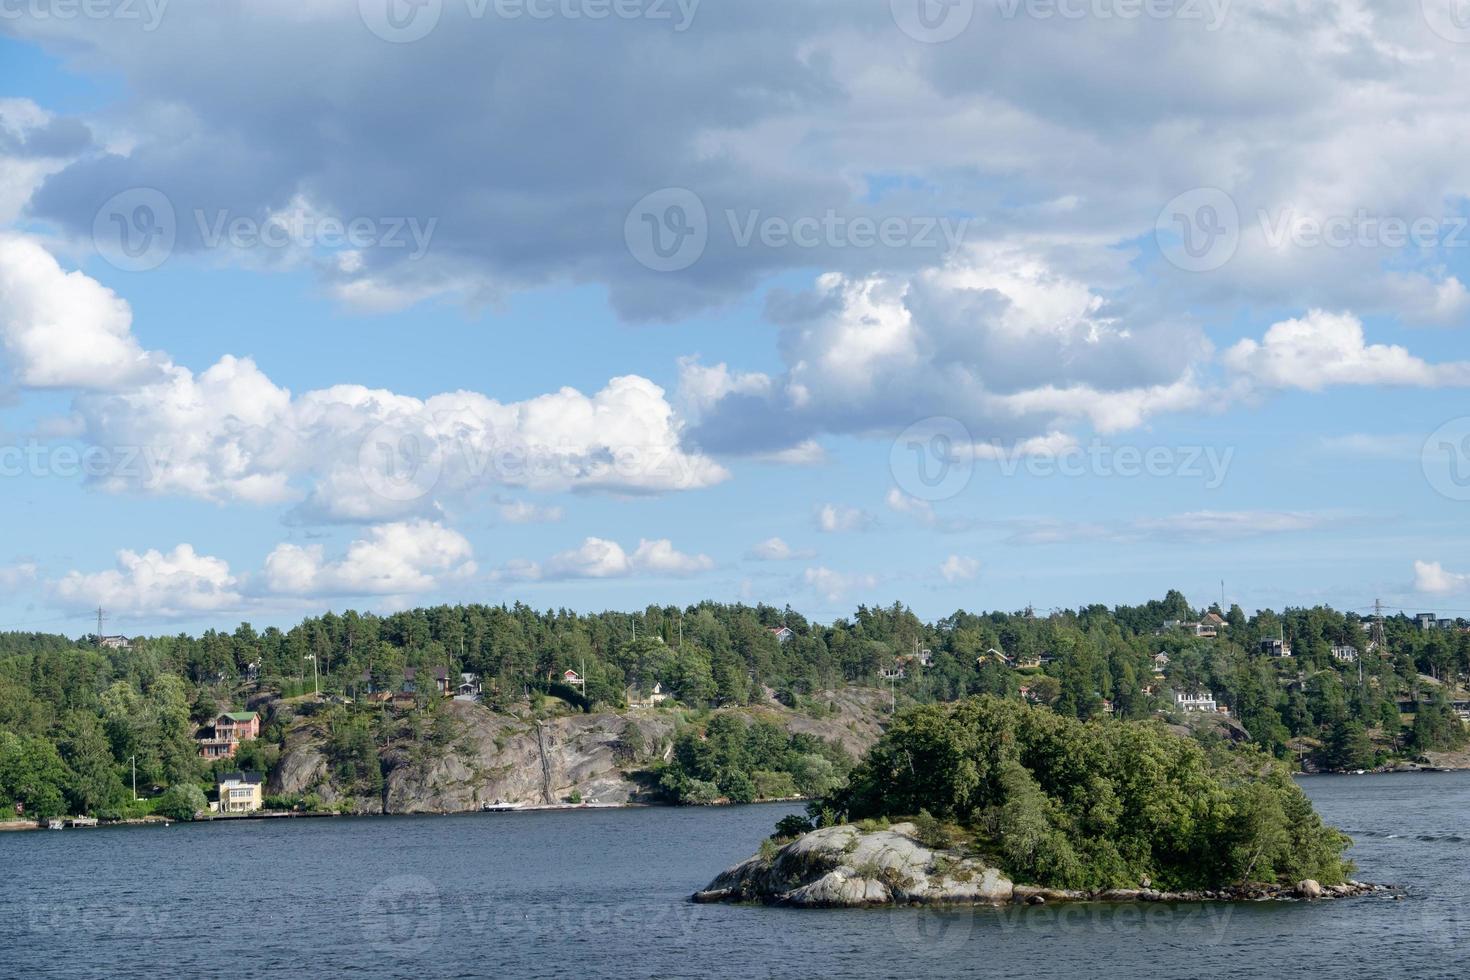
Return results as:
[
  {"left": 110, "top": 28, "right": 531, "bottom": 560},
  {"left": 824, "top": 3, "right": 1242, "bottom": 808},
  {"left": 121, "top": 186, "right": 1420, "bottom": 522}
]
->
[{"left": 0, "top": 592, "right": 1470, "bottom": 814}]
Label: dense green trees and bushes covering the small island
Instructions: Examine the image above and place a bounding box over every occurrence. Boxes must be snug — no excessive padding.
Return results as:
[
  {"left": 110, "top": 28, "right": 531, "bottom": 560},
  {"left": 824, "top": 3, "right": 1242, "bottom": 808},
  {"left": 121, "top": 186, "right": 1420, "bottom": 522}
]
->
[{"left": 829, "top": 696, "right": 1349, "bottom": 889}]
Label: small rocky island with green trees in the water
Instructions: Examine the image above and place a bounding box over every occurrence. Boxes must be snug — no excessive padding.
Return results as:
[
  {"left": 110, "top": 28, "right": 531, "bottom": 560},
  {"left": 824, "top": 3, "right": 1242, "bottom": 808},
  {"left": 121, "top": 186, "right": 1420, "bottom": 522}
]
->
[{"left": 694, "top": 696, "right": 1388, "bottom": 908}]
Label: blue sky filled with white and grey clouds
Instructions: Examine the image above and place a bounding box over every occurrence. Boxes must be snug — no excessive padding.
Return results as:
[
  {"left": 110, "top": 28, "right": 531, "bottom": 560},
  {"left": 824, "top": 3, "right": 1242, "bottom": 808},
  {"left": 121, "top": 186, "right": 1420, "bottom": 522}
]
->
[{"left": 0, "top": 0, "right": 1470, "bottom": 635}]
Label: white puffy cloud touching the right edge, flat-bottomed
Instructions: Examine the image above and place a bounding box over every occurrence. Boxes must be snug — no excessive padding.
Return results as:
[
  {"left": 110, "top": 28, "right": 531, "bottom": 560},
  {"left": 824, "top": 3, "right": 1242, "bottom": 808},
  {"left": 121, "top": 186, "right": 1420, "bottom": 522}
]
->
[{"left": 1222, "top": 310, "right": 1470, "bottom": 391}]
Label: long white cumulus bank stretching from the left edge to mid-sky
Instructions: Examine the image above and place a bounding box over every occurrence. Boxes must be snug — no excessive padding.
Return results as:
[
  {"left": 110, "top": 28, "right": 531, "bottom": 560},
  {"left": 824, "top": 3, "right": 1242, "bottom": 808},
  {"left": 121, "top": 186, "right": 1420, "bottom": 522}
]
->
[{"left": 0, "top": 237, "right": 729, "bottom": 523}]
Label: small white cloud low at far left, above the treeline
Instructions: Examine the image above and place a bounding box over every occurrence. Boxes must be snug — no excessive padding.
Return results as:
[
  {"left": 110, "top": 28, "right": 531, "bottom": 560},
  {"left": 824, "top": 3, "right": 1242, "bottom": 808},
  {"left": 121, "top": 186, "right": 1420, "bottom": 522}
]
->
[{"left": 51, "top": 544, "right": 241, "bottom": 617}]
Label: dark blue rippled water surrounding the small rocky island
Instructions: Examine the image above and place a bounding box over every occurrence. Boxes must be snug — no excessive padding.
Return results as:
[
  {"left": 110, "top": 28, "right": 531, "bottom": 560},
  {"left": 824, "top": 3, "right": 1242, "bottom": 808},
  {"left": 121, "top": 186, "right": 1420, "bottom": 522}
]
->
[{"left": 0, "top": 773, "right": 1470, "bottom": 980}]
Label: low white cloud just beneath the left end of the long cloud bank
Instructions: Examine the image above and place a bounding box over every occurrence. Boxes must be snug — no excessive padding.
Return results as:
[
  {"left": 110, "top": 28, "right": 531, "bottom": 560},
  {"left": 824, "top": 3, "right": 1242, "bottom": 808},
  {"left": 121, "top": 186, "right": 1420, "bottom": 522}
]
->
[{"left": 265, "top": 520, "right": 475, "bottom": 597}]
